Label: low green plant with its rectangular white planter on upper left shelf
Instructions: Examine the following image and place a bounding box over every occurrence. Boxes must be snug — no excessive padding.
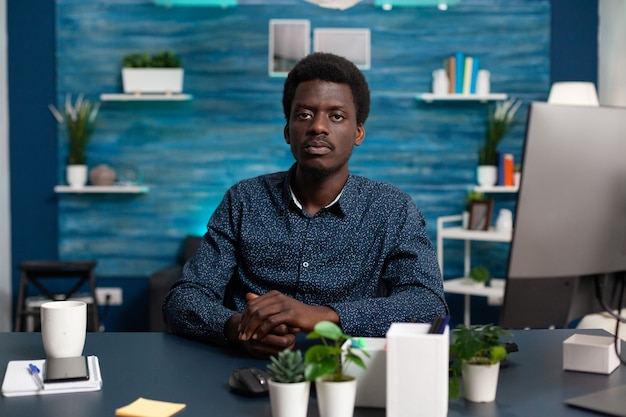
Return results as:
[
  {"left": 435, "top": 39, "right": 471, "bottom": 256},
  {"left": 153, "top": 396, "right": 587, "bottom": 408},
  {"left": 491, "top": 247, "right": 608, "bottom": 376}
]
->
[{"left": 122, "top": 51, "right": 184, "bottom": 94}]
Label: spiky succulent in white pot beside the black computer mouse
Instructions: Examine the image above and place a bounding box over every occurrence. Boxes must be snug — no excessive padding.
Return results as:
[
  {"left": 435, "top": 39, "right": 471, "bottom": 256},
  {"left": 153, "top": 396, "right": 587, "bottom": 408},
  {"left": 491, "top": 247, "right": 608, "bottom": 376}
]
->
[{"left": 267, "top": 349, "right": 311, "bottom": 417}]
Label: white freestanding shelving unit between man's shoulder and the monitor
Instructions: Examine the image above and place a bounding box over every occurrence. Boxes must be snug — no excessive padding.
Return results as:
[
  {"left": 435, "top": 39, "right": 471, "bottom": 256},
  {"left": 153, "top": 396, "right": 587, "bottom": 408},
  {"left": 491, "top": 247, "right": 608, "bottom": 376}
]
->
[{"left": 437, "top": 214, "right": 512, "bottom": 325}]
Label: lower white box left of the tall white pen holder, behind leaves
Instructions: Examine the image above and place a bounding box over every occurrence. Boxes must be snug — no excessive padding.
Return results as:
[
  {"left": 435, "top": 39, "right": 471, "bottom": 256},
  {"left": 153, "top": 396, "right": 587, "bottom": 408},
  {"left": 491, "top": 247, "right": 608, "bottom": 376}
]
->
[{"left": 344, "top": 337, "right": 387, "bottom": 408}]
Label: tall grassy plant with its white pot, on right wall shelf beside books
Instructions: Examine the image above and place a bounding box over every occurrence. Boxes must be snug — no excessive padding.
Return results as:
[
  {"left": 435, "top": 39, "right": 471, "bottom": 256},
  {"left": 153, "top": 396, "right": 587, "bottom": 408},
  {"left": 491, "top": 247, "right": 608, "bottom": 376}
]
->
[{"left": 476, "top": 99, "right": 522, "bottom": 186}]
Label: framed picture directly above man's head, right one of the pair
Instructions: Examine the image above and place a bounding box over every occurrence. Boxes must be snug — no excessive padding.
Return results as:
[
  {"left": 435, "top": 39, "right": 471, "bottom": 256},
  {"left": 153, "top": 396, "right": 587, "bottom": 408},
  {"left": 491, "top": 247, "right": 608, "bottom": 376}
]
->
[{"left": 313, "top": 28, "right": 371, "bottom": 69}]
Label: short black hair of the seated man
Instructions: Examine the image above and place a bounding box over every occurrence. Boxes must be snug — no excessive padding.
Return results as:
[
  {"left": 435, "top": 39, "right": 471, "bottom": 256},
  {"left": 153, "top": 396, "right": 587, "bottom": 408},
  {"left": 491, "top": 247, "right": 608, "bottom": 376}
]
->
[{"left": 283, "top": 52, "right": 370, "bottom": 125}]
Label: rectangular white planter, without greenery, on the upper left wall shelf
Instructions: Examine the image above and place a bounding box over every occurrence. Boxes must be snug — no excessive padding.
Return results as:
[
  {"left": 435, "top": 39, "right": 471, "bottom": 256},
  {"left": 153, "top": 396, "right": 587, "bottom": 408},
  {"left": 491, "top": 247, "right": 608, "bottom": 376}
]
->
[{"left": 122, "top": 68, "right": 184, "bottom": 94}]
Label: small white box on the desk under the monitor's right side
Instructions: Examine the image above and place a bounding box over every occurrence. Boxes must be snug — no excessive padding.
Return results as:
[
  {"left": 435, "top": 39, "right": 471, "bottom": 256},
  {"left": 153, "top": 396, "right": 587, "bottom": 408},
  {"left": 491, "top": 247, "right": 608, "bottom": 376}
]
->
[{"left": 563, "top": 334, "right": 620, "bottom": 375}]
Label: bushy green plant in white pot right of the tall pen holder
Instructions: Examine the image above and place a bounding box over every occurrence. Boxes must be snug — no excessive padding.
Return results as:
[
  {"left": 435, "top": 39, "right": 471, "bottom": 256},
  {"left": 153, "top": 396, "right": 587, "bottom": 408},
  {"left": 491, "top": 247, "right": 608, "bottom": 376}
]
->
[{"left": 448, "top": 324, "right": 512, "bottom": 402}]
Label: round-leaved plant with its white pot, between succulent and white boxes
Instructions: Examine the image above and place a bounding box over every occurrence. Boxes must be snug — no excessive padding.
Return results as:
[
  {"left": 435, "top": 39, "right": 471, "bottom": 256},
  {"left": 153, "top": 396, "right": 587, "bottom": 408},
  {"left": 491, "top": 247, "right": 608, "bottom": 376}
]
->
[{"left": 304, "top": 321, "right": 369, "bottom": 417}]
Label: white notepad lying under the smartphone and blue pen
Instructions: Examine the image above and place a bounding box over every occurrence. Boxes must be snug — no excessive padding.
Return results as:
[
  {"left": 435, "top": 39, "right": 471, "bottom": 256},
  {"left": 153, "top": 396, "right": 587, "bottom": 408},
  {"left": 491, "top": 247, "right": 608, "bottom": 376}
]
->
[{"left": 2, "top": 356, "right": 102, "bottom": 397}]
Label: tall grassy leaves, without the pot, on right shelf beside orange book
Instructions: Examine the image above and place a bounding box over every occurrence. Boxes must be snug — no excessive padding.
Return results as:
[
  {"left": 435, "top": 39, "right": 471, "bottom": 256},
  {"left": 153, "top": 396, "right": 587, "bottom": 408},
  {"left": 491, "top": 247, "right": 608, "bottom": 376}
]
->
[{"left": 478, "top": 99, "right": 522, "bottom": 165}]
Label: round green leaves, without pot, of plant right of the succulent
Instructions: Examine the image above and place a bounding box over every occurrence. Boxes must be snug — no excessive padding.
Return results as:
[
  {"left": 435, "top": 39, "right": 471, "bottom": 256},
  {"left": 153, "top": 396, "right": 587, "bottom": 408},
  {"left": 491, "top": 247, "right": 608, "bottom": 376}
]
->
[{"left": 304, "top": 321, "right": 369, "bottom": 382}]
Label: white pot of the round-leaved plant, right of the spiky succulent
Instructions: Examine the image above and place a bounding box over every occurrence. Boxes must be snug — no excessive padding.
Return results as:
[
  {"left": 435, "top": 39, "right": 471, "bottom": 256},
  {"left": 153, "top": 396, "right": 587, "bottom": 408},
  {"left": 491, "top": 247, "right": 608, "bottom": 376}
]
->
[{"left": 315, "top": 378, "right": 356, "bottom": 417}]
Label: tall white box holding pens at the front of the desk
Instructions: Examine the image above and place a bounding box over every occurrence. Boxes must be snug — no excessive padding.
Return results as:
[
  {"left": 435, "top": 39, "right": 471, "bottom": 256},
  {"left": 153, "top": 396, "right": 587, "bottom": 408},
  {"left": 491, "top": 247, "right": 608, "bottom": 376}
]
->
[{"left": 387, "top": 323, "right": 450, "bottom": 417}]
